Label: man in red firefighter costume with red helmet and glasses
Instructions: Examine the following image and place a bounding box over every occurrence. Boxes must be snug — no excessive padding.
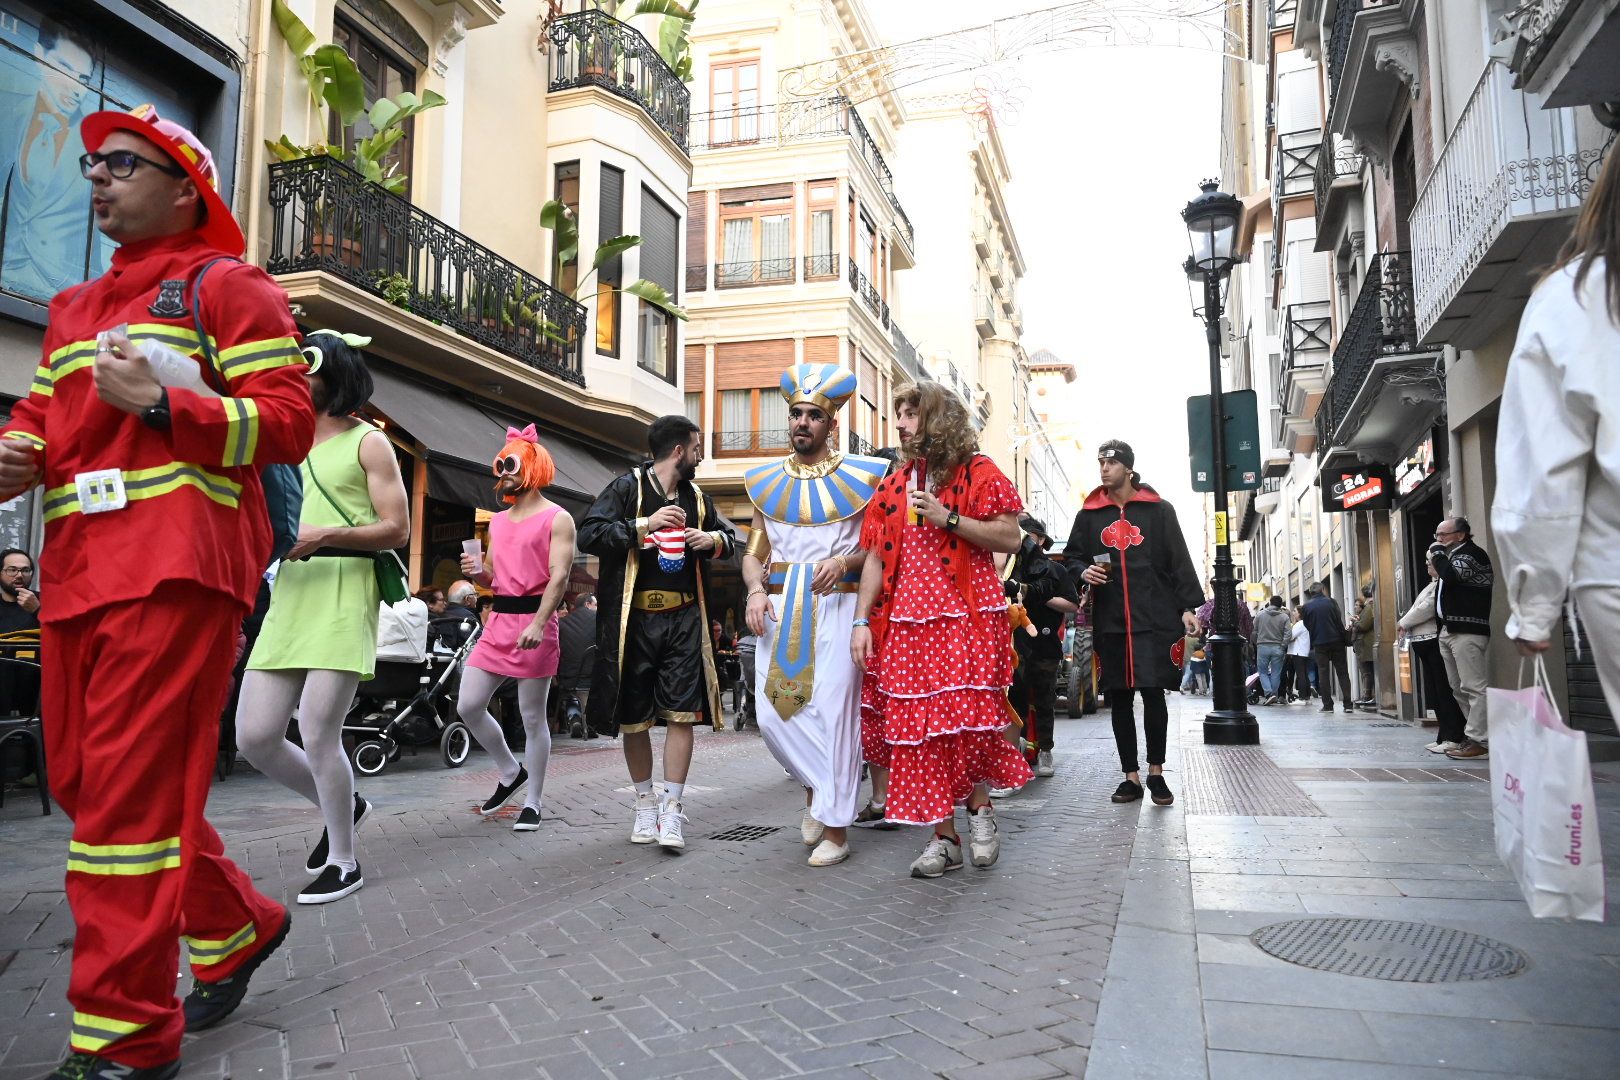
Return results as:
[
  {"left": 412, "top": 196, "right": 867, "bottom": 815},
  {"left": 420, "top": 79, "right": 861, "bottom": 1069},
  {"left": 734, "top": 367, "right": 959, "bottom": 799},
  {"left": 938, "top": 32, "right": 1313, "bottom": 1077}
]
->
[{"left": 0, "top": 105, "right": 314, "bottom": 1080}]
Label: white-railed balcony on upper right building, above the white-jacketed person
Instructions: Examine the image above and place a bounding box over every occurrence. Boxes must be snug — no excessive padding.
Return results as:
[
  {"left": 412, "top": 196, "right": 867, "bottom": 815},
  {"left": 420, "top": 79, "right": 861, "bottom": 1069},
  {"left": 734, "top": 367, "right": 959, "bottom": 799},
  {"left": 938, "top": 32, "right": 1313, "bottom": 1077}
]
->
[{"left": 1411, "top": 65, "right": 1602, "bottom": 348}]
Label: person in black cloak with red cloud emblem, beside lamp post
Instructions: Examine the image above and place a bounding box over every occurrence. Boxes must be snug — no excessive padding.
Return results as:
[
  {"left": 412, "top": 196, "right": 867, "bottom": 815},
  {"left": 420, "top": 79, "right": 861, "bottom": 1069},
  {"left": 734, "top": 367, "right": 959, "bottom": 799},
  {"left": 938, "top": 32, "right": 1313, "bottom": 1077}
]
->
[{"left": 1064, "top": 439, "right": 1204, "bottom": 806}]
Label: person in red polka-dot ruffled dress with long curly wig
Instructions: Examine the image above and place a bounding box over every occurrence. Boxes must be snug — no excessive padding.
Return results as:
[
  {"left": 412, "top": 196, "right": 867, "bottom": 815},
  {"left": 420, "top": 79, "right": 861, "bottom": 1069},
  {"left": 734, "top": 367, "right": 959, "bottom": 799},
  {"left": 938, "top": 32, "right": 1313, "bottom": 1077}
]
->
[{"left": 851, "top": 381, "right": 1032, "bottom": 878}]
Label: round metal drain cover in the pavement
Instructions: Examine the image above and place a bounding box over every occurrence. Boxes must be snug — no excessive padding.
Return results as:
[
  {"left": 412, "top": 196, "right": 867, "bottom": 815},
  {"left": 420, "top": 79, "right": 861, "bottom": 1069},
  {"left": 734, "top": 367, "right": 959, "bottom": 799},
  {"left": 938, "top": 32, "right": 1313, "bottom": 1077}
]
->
[{"left": 1249, "top": 918, "right": 1528, "bottom": 983}]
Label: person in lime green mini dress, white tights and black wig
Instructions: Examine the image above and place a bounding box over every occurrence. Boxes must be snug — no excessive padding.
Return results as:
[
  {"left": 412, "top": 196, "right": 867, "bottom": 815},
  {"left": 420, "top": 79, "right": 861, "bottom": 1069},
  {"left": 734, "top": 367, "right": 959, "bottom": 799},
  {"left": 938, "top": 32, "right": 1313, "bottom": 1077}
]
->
[{"left": 237, "top": 330, "right": 410, "bottom": 904}]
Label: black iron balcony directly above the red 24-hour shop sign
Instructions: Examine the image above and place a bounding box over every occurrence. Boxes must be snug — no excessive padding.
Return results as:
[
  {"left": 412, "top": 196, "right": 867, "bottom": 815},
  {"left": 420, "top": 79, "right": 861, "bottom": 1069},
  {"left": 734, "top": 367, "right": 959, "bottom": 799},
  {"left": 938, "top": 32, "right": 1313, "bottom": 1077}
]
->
[{"left": 1322, "top": 251, "right": 1445, "bottom": 460}]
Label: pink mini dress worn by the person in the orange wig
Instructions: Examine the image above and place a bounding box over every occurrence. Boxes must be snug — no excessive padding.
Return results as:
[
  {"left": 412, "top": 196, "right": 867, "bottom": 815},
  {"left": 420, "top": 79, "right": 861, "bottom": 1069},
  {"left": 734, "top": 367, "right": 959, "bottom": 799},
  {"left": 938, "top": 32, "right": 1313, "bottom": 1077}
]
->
[{"left": 467, "top": 505, "right": 562, "bottom": 678}]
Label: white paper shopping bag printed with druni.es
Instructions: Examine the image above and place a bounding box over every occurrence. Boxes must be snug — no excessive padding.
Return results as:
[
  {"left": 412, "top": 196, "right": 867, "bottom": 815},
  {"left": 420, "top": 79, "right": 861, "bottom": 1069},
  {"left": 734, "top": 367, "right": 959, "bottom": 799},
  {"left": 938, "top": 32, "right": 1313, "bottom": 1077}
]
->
[{"left": 1487, "top": 657, "right": 1604, "bottom": 923}]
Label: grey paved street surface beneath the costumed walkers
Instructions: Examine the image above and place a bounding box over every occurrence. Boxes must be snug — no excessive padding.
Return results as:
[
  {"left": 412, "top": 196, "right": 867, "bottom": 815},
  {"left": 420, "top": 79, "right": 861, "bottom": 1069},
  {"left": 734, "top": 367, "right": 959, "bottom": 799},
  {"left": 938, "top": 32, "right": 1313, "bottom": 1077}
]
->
[{"left": 0, "top": 695, "right": 1620, "bottom": 1080}]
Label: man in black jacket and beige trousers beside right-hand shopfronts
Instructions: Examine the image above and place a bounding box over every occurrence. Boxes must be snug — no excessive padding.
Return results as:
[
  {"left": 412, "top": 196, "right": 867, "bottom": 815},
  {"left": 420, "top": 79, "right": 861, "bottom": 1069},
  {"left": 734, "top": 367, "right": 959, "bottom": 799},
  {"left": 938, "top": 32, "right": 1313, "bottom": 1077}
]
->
[{"left": 1429, "top": 517, "right": 1490, "bottom": 761}]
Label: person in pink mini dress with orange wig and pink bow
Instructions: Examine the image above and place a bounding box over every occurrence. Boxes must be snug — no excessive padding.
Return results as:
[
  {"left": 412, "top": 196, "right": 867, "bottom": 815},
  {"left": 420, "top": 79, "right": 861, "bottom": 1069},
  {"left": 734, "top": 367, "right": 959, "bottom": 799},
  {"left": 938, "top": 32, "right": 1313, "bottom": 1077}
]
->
[{"left": 455, "top": 424, "right": 573, "bottom": 832}]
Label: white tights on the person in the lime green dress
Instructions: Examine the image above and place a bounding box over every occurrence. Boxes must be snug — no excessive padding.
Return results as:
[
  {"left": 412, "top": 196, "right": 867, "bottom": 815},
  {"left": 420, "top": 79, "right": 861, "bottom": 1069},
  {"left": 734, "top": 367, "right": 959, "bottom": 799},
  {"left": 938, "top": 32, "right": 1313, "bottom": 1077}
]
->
[{"left": 237, "top": 669, "right": 360, "bottom": 865}]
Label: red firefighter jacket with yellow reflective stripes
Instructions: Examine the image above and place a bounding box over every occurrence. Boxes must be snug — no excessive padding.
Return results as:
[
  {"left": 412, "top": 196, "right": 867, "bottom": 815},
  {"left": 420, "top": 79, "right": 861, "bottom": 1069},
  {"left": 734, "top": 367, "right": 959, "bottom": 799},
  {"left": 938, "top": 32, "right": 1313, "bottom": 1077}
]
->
[{"left": 0, "top": 233, "right": 314, "bottom": 622}]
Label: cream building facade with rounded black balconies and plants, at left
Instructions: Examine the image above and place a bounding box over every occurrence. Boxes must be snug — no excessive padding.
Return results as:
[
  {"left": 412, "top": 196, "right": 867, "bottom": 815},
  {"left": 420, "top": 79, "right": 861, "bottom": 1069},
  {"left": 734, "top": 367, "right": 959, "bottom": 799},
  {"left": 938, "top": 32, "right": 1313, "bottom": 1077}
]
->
[{"left": 0, "top": 0, "right": 690, "bottom": 591}]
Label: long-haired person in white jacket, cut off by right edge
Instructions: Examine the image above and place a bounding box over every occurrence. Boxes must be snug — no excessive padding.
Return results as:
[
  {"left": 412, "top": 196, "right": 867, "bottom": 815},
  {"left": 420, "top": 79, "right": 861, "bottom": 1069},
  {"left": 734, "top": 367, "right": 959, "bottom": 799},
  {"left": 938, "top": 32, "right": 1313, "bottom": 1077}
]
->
[{"left": 1490, "top": 143, "right": 1620, "bottom": 716}]
